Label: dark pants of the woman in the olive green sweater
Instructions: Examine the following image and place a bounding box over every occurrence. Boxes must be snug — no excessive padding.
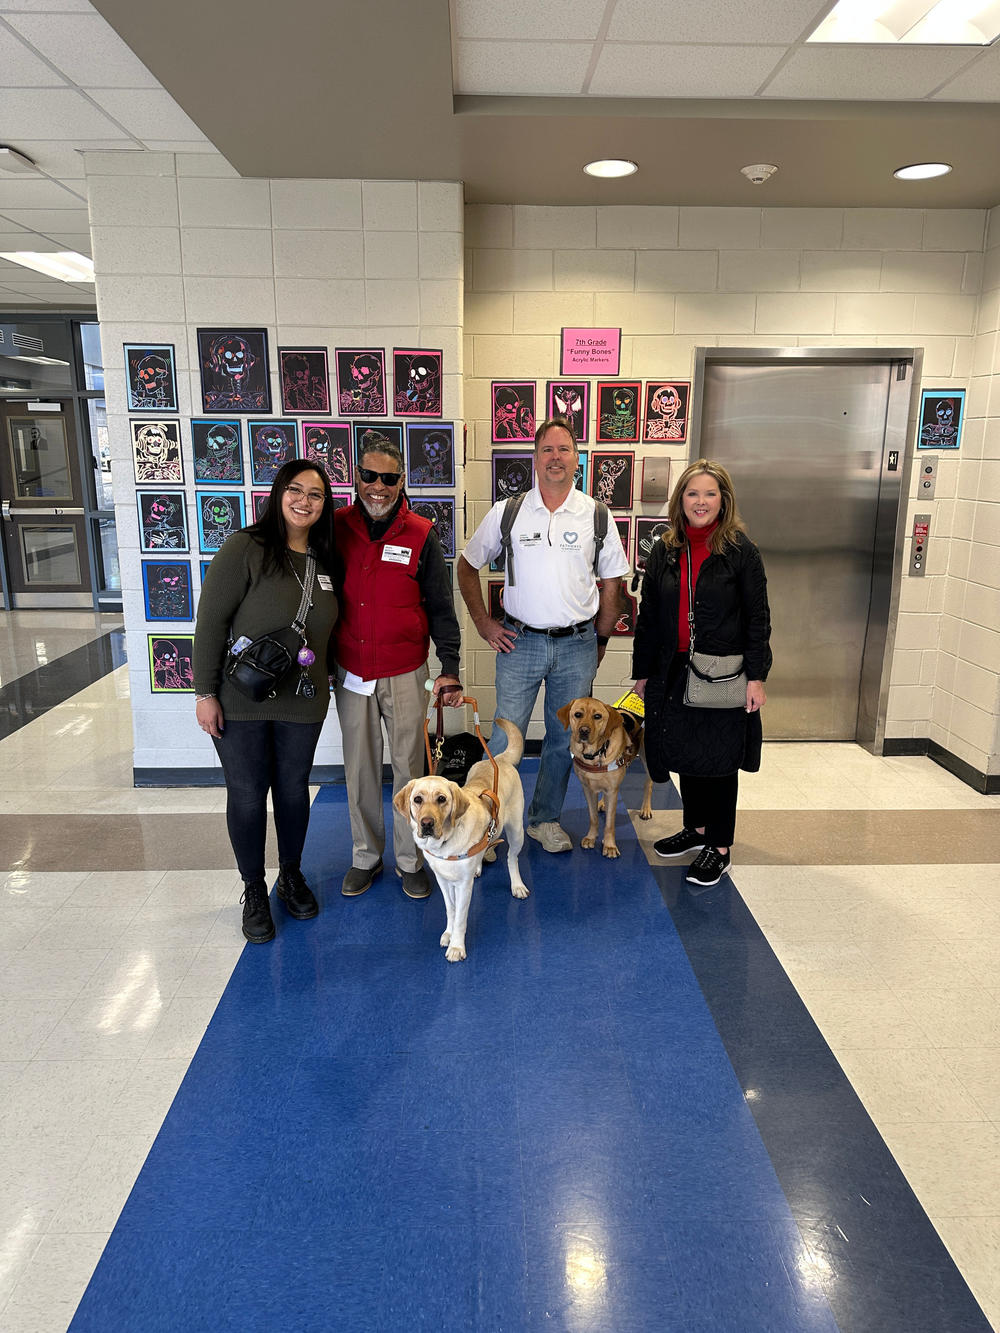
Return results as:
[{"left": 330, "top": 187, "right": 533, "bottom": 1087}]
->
[{"left": 215, "top": 721, "right": 323, "bottom": 881}]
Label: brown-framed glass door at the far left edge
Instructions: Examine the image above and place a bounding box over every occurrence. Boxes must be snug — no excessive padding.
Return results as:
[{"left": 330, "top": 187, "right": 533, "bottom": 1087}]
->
[{"left": 0, "top": 400, "right": 93, "bottom": 608}]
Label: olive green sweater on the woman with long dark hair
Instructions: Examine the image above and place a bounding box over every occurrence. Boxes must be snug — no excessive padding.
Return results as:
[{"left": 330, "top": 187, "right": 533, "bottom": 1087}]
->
[{"left": 195, "top": 531, "right": 337, "bottom": 722}]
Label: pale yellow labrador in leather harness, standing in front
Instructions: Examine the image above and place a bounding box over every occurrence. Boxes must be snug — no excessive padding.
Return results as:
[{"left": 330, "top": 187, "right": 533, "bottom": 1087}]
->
[{"left": 392, "top": 717, "right": 531, "bottom": 962}]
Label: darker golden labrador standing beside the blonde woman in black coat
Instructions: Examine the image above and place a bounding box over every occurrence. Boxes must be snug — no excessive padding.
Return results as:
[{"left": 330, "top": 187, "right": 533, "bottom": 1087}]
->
[{"left": 556, "top": 697, "right": 653, "bottom": 857}]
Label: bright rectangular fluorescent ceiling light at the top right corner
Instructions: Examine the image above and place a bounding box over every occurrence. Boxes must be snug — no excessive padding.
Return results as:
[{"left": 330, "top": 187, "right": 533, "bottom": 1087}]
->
[{"left": 809, "top": 0, "right": 1000, "bottom": 47}]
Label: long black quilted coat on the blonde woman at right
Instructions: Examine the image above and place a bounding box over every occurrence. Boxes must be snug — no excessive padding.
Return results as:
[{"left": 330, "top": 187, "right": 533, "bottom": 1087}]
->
[{"left": 632, "top": 533, "right": 771, "bottom": 782}]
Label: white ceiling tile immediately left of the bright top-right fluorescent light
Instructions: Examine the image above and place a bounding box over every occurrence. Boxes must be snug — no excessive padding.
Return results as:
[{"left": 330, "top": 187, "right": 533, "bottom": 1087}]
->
[{"left": 608, "top": 0, "right": 829, "bottom": 45}]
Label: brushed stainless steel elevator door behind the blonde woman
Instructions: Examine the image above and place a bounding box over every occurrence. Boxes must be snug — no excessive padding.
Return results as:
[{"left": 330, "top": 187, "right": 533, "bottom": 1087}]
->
[{"left": 701, "top": 361, "right": 892, "bottom": 741}]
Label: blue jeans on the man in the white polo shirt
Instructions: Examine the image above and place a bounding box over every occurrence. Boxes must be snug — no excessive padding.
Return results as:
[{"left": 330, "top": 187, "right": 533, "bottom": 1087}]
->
[{"left": 493, "top": 621, "right": 597, "bottom": 824}]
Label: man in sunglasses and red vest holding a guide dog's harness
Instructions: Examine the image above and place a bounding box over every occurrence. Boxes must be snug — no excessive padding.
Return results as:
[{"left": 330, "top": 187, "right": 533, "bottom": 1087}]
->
[{"left": 333, "top": 431, "right": 463, "bottom": 898}]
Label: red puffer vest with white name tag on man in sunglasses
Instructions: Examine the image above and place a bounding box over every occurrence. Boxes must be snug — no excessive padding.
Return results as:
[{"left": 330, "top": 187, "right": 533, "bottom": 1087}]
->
[{"left": 333, "top": 497, "right": 432, "bottom": 680}]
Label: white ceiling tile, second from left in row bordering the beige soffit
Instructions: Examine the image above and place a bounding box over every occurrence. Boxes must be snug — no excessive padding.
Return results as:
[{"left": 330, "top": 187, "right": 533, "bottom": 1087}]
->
[{"left": 591, "top": 43, "right": 784, "bottom": 97}]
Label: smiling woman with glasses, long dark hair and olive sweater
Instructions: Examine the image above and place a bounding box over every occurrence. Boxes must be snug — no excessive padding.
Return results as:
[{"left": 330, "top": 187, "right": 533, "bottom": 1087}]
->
[{"left": 193, "top": 459, "right": 337, "bottom": 944}]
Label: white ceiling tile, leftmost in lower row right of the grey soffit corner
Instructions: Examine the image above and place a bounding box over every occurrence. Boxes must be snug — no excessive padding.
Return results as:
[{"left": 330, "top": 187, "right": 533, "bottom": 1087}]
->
[{"left": 455, "top": 41, "right": 593, "bottom": 97}]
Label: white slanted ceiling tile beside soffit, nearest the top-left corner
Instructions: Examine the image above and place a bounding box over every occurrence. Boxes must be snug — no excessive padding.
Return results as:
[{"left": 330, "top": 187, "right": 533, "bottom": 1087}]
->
[{"left": 7, "top": 12, "right": 159, "bottom": 88}]
